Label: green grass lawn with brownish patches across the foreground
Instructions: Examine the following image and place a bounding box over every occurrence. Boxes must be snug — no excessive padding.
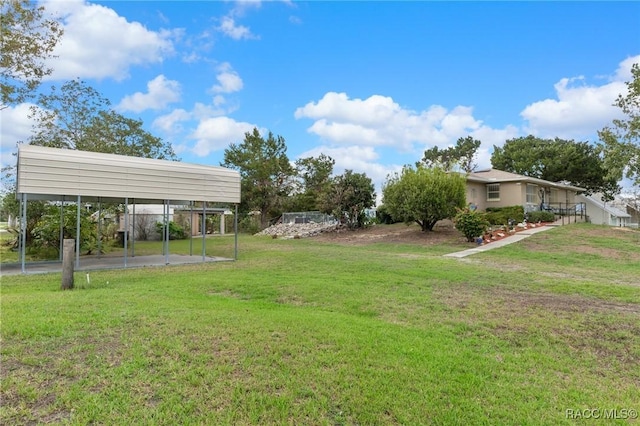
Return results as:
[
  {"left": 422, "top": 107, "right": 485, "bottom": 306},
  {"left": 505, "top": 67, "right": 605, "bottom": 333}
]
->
[{"left": 0, "top": 224, "right": 640, "bottom": 425}]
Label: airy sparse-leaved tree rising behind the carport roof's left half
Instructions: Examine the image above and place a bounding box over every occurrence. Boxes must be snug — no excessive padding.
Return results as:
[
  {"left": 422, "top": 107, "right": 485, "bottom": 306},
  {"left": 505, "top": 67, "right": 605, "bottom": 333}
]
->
[{"left": 29, "top": 79, "right": 176, "bottom": 160}]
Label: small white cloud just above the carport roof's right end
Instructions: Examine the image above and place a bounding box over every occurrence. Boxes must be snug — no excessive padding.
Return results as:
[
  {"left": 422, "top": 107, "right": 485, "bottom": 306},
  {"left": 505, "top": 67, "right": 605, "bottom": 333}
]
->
[{"left": 191, "top": 117, "right": 257, "bottom": 157}]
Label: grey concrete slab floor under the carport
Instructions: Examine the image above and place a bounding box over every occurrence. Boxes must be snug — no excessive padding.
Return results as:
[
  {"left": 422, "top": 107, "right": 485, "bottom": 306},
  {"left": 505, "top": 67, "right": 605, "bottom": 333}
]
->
[{"left": 0, "top": 254, "right": 234, "bottom": 276}]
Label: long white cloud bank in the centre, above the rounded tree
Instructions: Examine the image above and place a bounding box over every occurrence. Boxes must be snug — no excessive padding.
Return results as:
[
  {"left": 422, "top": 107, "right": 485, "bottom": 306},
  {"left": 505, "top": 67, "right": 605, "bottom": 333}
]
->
[{"left": 294, "top": 92, "right": 514, "bottom": 152}]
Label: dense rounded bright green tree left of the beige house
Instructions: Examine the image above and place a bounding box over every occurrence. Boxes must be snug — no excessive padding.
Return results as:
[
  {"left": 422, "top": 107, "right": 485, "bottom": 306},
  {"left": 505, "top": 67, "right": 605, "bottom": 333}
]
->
[{"left": 382, "top": 165, "right": 466, "bottom": 232}]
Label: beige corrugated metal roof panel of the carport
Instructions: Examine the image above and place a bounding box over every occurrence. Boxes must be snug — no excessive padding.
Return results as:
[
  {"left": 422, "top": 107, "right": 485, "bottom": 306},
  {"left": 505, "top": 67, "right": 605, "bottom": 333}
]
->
[{"left": 17, "top": 145, "right": 240, "bottom": 203}]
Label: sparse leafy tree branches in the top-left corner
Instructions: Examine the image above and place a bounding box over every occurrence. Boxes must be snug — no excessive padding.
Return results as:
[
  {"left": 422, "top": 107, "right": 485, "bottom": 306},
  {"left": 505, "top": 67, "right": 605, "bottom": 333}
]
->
[{"left": 0, "top": 0, "right": 62, "bottom": 109}]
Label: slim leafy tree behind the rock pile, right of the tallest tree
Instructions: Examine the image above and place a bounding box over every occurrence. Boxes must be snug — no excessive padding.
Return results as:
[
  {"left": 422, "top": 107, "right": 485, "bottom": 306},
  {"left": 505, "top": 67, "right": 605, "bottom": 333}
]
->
[{"left": 290, "top": 154, "right": 336, "bottom": 211}]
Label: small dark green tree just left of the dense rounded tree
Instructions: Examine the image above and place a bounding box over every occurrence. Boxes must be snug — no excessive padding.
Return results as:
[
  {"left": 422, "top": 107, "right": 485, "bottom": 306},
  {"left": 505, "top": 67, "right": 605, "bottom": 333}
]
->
[{"left": 321, "top": 170, "right": 376, "bottom": 229}]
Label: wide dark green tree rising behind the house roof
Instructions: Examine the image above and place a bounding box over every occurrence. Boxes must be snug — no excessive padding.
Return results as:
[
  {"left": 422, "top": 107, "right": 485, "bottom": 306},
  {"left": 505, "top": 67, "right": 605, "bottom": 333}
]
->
[{"left": 491, "top": 135, "right": 618, "bottom": 192}]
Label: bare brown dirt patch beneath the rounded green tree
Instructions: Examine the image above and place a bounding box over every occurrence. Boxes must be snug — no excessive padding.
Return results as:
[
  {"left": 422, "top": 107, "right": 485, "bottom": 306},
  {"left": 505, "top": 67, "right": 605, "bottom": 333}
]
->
[{"left": 311, "top": 223, "right": 462, "bottom": 245}]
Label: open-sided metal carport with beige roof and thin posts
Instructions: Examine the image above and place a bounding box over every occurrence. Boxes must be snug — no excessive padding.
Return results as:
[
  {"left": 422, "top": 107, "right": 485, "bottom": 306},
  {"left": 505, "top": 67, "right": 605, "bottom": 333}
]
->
[{"left": 16, "top": 145, "right": 240, "bottom": 273}]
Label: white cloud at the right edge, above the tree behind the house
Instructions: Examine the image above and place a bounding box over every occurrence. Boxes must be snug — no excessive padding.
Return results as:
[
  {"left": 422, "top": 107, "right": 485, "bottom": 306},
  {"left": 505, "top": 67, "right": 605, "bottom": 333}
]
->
[{"left": 520, "top": 56, "right": 640, "bottom": 139}]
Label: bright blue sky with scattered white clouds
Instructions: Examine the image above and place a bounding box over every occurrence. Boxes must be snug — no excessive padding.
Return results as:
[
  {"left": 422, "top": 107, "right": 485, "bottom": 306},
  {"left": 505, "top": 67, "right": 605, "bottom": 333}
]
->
[{"left": 0, "top": 0, "right": 640, "bottom": 199}]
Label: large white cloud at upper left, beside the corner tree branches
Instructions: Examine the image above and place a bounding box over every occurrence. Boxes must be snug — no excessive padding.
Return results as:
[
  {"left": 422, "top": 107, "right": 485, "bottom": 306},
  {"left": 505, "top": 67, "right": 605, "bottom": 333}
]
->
[{"left": 44, "top": 0, "right": 174, "bottom": 80}]
